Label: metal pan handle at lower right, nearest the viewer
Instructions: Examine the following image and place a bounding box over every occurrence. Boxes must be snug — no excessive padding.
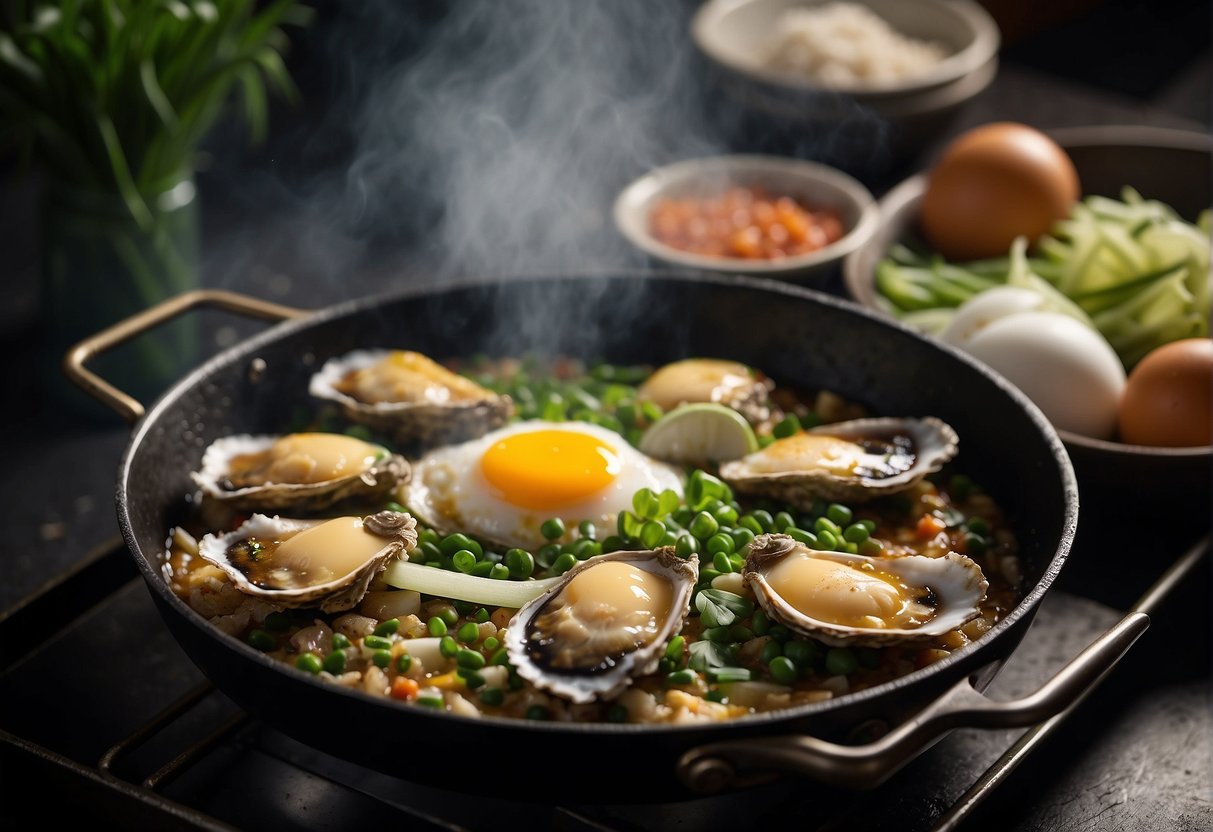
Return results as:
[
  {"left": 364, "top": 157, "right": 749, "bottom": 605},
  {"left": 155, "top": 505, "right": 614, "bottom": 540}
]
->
[{"left": 678, "top": 612, "right": 1150, "bottom": 794}]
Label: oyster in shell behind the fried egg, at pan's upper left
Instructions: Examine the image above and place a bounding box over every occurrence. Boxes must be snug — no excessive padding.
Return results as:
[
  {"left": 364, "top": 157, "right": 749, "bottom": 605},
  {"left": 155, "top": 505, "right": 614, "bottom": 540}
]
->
[{"left": 308, "top": 349, "right": 514, "bottom": 446}]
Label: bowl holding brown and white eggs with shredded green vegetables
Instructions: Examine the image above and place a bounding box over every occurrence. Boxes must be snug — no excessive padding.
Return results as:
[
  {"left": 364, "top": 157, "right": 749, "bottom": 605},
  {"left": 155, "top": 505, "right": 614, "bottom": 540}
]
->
[{"left": 843, "top": 122, "right": 1213, "bottom": 512}]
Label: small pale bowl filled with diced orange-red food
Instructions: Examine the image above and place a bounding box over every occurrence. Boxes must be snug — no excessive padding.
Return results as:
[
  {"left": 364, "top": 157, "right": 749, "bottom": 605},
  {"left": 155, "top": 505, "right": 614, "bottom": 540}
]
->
[{"left": 614, "top": 154, "right": 878, "bottom": 281}]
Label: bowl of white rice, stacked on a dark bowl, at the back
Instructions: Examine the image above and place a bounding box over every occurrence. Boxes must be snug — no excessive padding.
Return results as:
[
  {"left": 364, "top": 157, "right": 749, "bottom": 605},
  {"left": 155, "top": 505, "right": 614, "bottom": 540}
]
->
[{"left": 690, "top": 0, "right": 1001, "bottom": 178}]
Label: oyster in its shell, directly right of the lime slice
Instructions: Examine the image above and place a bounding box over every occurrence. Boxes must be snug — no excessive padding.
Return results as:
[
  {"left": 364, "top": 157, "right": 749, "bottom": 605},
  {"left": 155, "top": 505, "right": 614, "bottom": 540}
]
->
[{"left": 721, "top": 416, "right": 958, "bottom": 509}]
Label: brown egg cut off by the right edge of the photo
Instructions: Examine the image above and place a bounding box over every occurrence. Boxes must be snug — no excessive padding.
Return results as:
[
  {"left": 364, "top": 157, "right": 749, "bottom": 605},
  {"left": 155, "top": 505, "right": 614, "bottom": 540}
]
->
[{"left": 1120, "top": 338, "right": 1213, "bottom": 448}]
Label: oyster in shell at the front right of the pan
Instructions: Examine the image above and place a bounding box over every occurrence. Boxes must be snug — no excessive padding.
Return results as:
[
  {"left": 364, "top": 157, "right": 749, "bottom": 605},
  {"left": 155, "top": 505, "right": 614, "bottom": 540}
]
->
[{"left": 741, "top": 535, "right": 990, "bottom": 646}]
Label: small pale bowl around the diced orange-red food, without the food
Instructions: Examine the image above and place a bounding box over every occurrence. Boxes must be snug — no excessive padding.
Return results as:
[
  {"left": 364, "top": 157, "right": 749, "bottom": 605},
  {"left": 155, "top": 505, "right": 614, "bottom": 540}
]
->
[{"left": 614, "top": 155, "right": 879, "bottom": 280}]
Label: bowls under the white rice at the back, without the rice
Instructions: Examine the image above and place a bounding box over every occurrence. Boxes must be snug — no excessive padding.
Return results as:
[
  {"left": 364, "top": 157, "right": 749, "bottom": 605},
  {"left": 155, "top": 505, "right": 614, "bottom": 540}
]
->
[{"left": 691, "top": 0, "right": 1002, "bottom": 172}]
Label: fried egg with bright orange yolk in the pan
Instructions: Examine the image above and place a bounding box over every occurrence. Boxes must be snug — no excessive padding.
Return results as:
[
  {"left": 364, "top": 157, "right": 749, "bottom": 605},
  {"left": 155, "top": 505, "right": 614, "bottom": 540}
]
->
[{"left": 403, "top": 421, "right": 682, "bottom": 551}]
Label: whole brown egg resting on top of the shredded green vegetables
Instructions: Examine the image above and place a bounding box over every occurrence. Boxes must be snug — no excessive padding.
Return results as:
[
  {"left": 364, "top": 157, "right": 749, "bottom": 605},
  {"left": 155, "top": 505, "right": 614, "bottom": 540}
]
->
[{"left": 921, "top": 121, "right": 1081, "bottom": 261}]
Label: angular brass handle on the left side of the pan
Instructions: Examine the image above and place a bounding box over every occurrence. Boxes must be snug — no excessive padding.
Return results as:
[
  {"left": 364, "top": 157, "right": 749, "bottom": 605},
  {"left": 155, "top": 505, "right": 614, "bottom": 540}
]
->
[{"left": 63, "top": 289, "right": 312, "bottom": 422}]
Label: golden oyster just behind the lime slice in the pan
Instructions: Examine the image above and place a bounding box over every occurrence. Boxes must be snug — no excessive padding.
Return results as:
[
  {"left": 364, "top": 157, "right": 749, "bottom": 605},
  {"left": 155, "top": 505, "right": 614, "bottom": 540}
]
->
[{"left": 637, "top": 358, "right": 773, "bottom": 424}]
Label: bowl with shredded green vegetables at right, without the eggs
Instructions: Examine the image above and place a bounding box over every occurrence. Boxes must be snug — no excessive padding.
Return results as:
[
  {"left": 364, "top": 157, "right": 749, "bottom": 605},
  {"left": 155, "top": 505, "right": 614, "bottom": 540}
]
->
[{"left": 843, "top": 126, "right": 1213, "bottom": 512}]
